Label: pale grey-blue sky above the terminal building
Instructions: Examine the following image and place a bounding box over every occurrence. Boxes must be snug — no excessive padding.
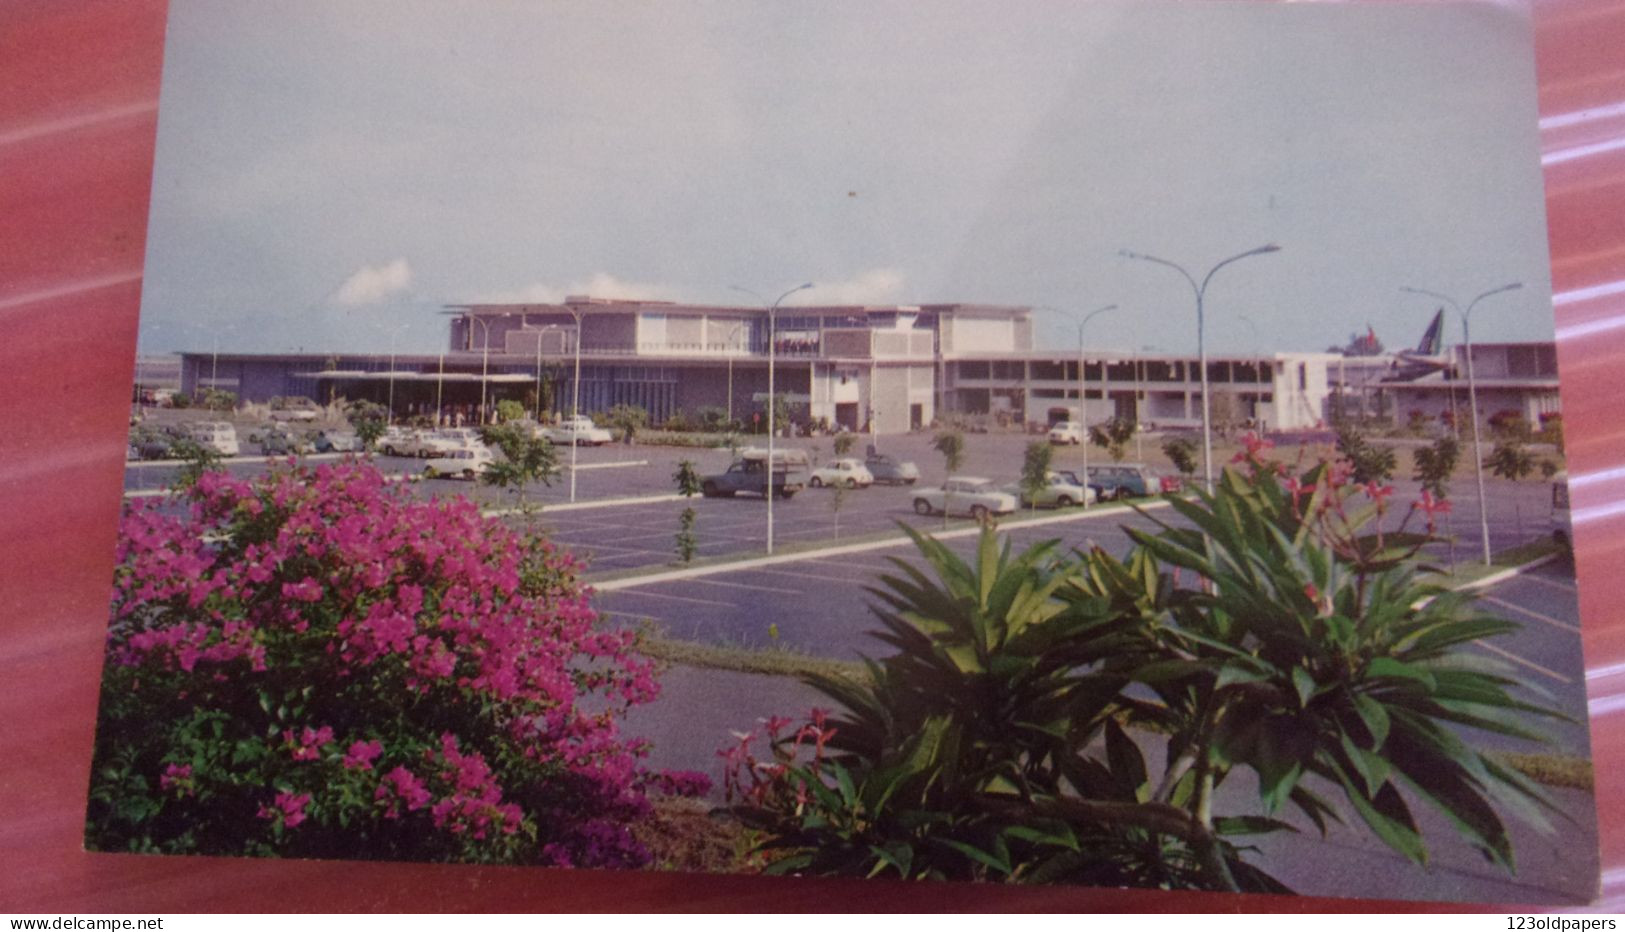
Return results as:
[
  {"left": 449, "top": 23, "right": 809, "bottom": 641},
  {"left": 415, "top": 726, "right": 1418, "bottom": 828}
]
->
[{"left": 140, "top": 0, "right": 1552, "bottom": 354}]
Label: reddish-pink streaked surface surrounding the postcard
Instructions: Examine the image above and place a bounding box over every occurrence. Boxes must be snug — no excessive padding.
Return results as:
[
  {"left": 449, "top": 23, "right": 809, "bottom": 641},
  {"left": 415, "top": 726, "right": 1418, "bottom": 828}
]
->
[{"left": 0, "top": 0, "right": 1625, "bottom": 913}]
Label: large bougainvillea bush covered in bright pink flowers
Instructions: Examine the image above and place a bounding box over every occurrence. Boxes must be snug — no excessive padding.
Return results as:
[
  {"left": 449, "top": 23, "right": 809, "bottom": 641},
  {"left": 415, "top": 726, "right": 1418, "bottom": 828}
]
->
[{"left": 86, "top": 461, "right": 705, "bottom": 867}]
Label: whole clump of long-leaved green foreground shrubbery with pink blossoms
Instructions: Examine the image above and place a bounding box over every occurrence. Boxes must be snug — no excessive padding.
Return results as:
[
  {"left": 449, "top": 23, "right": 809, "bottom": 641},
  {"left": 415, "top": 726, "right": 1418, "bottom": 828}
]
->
[{"left": 722, "top": 440, "right": 1560, "bottom": 891}]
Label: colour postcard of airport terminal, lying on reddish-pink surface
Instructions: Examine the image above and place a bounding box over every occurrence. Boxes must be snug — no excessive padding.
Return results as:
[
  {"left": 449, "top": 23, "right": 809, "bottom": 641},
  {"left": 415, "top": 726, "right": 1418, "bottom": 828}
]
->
[{"left": 85, "top": 0, "right": 1599, "bottom": 904}]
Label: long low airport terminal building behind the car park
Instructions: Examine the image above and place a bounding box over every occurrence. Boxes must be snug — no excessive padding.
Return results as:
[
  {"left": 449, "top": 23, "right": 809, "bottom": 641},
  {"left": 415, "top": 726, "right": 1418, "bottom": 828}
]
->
[{"left": 180, "top": 296, "right": 1557, "bottom": 434}]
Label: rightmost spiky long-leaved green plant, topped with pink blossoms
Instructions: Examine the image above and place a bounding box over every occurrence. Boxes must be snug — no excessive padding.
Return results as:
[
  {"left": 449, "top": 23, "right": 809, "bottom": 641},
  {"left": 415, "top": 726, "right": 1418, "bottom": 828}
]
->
[{"left": 1112, "top": 466, "right": 1560, "bottom": 870}]
